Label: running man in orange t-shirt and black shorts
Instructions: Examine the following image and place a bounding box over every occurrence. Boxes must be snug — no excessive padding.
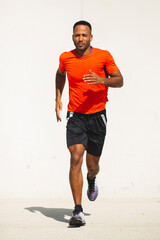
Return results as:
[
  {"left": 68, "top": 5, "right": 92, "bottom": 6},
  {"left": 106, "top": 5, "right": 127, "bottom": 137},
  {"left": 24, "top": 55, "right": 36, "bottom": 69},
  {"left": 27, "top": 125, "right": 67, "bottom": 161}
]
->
[{"left": 56, "top": 21, "right": 123, "bottom": 226}]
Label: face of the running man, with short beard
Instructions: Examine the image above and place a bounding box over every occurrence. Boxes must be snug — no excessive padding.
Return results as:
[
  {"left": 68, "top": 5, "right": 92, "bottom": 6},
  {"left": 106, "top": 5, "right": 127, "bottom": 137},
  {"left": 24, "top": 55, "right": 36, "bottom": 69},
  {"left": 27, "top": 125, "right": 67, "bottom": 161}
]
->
[{"left": 72, "top": 25, "right": 93, "bottom": 51}]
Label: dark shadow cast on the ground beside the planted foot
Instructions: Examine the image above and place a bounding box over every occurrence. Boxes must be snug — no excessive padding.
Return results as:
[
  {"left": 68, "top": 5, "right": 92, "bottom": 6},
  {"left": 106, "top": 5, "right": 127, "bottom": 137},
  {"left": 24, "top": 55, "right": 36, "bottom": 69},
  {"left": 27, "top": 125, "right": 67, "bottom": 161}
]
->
[{"left": 25, "top": 207, "right": 90, "bottom": 223}]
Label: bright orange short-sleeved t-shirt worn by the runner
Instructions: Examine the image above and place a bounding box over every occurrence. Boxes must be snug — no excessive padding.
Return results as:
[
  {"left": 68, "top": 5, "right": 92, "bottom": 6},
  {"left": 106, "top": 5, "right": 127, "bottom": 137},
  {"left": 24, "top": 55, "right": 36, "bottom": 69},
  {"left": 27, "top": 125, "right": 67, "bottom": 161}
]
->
[{"left": 59, "top": 48, "right": 118, "bottom": 114}]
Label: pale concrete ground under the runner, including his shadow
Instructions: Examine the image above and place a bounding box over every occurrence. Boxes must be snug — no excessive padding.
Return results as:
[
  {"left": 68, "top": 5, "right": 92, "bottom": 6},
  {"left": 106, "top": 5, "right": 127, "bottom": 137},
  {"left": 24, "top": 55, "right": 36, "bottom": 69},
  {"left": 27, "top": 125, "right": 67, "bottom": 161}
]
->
[{"left": 0, "top": 199, "right": 160, "bottom": 240}]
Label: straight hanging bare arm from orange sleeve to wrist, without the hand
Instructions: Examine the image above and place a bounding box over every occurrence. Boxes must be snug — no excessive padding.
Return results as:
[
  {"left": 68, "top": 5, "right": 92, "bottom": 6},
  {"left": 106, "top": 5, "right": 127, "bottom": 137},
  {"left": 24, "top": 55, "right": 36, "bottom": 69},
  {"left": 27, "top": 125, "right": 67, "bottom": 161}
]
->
[{"left": 56, "top": 71, "right": 66, "bottom": 101}]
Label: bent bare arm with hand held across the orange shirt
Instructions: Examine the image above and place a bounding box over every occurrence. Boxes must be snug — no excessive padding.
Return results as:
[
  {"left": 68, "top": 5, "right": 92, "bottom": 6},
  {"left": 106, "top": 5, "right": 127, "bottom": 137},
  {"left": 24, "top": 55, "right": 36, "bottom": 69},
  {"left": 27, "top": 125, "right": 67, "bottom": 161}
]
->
[{"left": 83, "top": 70, "right": 123, "bottom": 88}]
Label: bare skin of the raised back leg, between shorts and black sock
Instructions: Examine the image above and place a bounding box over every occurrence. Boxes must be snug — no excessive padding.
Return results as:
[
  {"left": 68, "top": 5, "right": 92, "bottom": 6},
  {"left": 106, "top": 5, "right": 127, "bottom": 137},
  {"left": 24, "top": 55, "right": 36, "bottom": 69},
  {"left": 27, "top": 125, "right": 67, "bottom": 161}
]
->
[{"left": 86, "top": 153, "right": 100, "bottom": 179}]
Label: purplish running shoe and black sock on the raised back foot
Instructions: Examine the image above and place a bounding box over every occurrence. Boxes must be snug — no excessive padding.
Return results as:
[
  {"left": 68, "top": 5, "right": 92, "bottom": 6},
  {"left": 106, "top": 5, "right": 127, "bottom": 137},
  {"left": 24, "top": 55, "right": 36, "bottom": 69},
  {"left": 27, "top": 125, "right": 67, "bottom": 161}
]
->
[{"left": 87, "top": 175, "right": 98, "bottom": 201}]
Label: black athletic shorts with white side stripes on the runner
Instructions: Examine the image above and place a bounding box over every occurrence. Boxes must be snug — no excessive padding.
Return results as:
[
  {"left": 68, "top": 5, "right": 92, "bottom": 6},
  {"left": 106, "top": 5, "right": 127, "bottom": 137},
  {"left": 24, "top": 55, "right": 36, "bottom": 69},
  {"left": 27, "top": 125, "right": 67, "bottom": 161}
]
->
[{"left": 67, "top": 109, "right": 107, "bottom": 156}]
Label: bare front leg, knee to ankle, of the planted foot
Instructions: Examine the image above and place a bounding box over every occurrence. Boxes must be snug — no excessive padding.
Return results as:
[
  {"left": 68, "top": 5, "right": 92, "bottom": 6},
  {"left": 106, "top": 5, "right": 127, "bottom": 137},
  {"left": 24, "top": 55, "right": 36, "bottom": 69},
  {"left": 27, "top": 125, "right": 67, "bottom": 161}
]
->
[{"left": 68, "top": 144, "right": 85, "bottom": 205}]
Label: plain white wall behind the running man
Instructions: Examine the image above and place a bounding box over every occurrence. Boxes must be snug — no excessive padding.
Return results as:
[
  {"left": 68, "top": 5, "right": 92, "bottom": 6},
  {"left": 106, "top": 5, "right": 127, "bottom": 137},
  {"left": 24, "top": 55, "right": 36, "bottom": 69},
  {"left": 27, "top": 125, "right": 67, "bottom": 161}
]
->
[{"left": 0, "top": 0, "right": 160, "bottom": 198}]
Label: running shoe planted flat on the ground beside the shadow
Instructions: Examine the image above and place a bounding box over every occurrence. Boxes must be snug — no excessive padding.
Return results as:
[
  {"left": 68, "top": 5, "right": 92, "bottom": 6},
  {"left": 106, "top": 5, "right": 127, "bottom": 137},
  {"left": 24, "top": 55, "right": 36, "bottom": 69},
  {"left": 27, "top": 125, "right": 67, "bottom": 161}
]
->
[{"left": 69, "top": 209, "right": 86, "bottom": 227}]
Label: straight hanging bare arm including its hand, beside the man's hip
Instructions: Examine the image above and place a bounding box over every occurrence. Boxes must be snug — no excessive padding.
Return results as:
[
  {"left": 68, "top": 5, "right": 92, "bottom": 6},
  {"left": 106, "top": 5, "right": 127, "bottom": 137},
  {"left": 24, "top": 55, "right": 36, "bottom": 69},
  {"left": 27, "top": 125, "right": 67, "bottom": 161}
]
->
[{"left": 55, "top": 69, "right": 66, "bottom": 122}]
